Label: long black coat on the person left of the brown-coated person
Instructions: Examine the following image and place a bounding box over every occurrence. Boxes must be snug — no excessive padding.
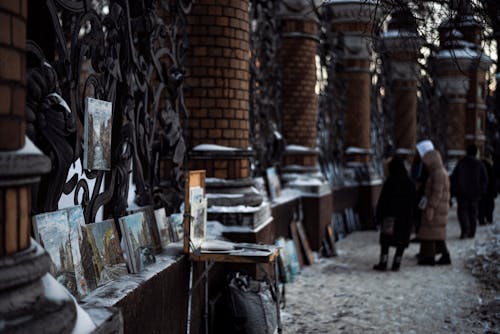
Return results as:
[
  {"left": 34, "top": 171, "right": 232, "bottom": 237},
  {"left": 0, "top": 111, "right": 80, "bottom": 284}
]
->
[{"left": 376, "top": 157, "right": 416, "bottom": 247}]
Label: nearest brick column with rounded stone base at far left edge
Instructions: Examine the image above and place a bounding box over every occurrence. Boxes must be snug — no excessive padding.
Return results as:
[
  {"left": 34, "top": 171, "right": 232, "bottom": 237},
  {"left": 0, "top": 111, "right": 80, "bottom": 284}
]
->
[{"left": 0, "top": 0, "right": 76, "bottom": 333}]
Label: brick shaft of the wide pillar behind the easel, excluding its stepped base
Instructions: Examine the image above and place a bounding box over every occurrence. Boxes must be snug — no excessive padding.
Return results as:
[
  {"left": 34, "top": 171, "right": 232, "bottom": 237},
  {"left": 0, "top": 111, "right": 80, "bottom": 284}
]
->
[{"left": 185, "top": 0, "right": 250, "bottom": 179}]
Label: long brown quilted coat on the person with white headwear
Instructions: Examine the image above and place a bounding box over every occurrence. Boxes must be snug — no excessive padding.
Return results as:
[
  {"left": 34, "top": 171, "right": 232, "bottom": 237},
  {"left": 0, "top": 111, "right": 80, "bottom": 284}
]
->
[{"left": 417, "top": 151, "right": 450, "bottom": 241}]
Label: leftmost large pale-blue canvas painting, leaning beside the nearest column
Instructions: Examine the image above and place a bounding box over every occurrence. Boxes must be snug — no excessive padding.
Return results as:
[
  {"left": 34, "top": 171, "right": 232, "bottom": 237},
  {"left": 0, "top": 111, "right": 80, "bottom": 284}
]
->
[{"left": 33, "top": 206, "right": 89, "bottom": 298}]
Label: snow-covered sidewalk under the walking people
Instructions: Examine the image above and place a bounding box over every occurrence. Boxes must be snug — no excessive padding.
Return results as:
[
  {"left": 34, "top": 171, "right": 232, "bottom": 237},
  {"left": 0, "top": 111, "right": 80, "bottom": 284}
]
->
[{"left": 282, "top": 201, "right": 500, "bottom": 334}]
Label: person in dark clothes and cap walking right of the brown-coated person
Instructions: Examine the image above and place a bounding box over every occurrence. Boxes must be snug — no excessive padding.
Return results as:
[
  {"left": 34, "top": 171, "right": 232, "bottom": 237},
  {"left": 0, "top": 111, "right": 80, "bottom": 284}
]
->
[{"left": 451, "top": 145, "right": 488, "bottom": 239}]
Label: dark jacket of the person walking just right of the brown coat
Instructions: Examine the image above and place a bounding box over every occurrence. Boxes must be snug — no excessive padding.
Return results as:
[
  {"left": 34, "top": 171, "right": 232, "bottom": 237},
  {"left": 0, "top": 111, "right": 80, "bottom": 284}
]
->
[{"left": 451, "top": 156, "right": 488, "bottom": 201}]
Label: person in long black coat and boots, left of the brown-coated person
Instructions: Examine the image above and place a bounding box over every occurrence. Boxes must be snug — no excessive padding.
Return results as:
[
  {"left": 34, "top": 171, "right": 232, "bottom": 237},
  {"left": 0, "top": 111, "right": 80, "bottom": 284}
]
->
[{"left": 373, "top": 156, "right": 416, "bottom": 271}]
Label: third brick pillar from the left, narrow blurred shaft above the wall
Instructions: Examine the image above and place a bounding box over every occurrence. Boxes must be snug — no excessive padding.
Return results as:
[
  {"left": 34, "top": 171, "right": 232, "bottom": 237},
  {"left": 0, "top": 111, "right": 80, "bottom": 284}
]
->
[{"left": 280, "top": 0, "right": 319, "bottom": 167}]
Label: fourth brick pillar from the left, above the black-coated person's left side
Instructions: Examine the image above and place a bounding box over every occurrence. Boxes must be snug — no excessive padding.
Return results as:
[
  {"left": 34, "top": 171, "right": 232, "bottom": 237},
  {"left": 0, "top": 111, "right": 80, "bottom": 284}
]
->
[{"left": 329, "top": 0, "right": 377, "bottom": 163}]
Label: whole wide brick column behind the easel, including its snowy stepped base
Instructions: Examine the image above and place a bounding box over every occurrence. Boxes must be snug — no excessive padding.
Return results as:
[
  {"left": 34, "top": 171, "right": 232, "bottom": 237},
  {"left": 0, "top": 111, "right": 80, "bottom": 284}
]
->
[{"left": 185, "top": 0, "right": 270, "bottom": 228}]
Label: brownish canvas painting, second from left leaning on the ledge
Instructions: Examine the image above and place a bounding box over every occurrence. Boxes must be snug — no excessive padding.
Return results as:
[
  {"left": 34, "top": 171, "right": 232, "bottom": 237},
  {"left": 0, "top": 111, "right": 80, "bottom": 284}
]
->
[{"left": 85, "top": 219, "right": 127, "bottom": 286}]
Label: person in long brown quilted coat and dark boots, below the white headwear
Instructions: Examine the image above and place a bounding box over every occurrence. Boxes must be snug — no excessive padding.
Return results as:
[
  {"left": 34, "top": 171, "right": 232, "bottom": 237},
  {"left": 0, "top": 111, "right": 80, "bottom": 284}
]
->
[{"left": 417, "top": 150, "right": 451, "bottom": 265}]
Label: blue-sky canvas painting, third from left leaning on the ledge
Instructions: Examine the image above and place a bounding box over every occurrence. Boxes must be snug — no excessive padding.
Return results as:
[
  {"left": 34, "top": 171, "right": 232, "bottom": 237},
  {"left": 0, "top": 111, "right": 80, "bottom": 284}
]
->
[{"left": 118, "top": 212, "right": 154, "bottom": 273}]
